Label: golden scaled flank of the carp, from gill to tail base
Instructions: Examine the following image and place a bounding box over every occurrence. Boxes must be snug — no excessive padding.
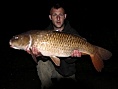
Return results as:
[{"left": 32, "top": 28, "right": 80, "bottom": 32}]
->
[{"left": 34, "top": 32, "right": 95, "bottom": 57}]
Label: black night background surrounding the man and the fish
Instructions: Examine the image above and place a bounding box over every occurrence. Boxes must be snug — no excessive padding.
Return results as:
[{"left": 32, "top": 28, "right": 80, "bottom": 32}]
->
[{"left": 0, "top": 0, "right": 118, "bottom": 89}]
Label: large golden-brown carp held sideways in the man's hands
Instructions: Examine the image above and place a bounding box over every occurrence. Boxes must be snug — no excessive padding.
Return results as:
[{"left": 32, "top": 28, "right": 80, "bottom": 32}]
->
[{"left": 9, "top": 30, "right": 112, "bottom": 72}]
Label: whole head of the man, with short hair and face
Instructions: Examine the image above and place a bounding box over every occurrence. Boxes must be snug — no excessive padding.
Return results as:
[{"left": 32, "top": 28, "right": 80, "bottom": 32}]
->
[{"left": 49, "top": 4, "right": 67, "bottom": 30}]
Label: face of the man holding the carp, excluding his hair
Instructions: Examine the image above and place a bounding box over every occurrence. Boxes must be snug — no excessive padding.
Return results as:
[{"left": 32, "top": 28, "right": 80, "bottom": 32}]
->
[{"left": 49, "top": 8, "right": 66, "bottom": 28}]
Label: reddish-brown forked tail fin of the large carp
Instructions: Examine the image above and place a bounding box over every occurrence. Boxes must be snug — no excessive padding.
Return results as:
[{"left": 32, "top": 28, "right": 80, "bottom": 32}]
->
[{"left": 90, "top": 46, "right": 112, "bottom": 72}]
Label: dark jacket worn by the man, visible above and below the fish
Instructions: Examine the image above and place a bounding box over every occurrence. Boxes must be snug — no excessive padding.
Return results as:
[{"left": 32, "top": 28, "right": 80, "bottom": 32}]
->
[{"left": 46, "top": 21, "right": 78, "bottom": 77}]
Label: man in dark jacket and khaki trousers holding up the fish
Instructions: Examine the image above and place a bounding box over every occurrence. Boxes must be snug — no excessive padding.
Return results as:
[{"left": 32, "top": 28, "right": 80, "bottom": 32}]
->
[{"left": 29, "top": 4, "right": 81, "bottom": 88}]
